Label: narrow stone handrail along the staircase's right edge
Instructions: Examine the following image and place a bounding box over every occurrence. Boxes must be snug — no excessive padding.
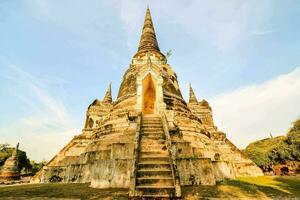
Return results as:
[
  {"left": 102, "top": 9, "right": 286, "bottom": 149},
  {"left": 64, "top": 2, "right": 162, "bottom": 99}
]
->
[{"left": 161, "top": 112, "right": 181, "bottom": 197}]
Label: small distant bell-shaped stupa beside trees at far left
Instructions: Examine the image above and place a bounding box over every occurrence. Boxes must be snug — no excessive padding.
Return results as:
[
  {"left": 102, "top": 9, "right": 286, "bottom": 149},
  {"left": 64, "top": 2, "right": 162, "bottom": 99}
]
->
[{"left": 0, "top": 143, "right": 20, "bottom": 181}]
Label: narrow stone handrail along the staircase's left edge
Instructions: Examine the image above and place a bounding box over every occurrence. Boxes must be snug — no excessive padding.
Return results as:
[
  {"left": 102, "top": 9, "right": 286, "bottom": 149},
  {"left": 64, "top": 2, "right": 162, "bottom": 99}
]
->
[{"left": 129, "top": 113, "right": 142, "bottom": 197}]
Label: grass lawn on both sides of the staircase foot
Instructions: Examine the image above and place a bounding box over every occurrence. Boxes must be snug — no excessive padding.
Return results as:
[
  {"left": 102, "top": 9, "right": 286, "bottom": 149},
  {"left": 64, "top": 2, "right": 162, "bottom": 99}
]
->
[{"left": 0, "top": 176, "right": 300, "bottom": 200}]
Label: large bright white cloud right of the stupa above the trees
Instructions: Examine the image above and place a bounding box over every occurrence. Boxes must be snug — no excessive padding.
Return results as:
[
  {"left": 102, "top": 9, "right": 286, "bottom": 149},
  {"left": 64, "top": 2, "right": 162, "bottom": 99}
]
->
[{"left": 212, "top": 67, "right": 300, "bottom": 148}]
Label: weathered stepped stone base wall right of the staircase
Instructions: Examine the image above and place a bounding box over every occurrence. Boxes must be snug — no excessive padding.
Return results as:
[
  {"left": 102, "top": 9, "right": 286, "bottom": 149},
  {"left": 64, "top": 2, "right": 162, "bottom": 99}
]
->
[{"left": 167, "top": 109, "right": 263, "bottom": 185}]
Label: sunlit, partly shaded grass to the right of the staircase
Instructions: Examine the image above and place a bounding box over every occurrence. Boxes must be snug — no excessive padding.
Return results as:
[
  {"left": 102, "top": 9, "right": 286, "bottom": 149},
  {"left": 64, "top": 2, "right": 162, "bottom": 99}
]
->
[{"left": 182, "top": 177, "right": 300, "bottom": 199}]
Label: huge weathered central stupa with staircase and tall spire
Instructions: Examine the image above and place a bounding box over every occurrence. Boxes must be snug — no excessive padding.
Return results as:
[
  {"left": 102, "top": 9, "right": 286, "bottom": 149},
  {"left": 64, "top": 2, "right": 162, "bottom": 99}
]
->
[{"left": 32, "top": 8, "right": 262, "bottom": 198}]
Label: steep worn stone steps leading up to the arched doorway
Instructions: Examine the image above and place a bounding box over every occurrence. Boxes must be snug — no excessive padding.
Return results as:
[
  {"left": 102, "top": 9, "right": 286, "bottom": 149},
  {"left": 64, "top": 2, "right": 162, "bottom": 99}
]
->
[{"left": 135, "top": 115, "right": 175, "bottom": 199}]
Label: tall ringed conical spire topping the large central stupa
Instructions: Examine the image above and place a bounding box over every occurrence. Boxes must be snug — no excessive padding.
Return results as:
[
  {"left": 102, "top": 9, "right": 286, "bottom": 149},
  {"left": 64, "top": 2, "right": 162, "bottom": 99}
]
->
[{"left": 136, "top": 6, "right": 162, "bottom": 55}]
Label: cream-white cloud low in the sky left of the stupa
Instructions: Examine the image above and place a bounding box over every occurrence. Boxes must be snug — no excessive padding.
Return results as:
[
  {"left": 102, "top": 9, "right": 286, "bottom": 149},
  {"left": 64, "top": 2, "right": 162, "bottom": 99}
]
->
[{"left": 0, "top": 116, "right": 79, "bottom": 161}]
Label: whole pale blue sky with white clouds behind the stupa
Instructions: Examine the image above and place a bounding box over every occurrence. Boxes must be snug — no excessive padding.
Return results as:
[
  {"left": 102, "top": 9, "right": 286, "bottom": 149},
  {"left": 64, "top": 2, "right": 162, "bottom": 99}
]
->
[{"left": 0, "top": 0, "right": 300, "bottom": 160}]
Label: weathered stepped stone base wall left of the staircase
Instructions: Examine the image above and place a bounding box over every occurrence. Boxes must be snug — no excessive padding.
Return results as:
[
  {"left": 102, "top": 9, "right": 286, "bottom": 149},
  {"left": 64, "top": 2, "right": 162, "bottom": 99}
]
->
[{"left": 32, "top": 113, "right": 136, "bottom": 188}]
